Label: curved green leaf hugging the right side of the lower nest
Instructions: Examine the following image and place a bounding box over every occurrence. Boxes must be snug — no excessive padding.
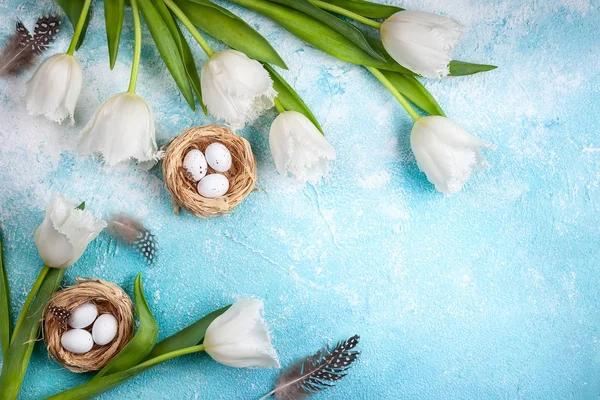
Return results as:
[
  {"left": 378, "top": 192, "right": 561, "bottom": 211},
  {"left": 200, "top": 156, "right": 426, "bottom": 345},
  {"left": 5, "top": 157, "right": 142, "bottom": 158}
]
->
[{"left": 94, "top": 274, "right": 158, "bottom": 380}]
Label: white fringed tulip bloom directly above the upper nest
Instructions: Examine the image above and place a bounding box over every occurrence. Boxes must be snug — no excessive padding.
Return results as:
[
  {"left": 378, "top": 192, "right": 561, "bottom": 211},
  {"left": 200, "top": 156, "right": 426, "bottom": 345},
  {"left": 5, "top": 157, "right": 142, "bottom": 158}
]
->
[{"left": 200, "top": 50, "right": 277, "bottom": 130}]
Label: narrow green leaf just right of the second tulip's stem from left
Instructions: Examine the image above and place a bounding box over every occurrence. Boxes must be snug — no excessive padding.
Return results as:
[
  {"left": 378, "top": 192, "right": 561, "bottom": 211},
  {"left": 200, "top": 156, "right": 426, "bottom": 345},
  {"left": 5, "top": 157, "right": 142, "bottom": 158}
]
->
[{"left": 138, "top": 0, "right": 196, "bottom": 110}]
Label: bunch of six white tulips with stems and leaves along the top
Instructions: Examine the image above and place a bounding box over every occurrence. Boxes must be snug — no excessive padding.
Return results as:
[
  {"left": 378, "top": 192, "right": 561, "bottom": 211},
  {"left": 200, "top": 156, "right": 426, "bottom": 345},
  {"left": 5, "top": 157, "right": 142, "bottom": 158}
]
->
[{"left": 26, "top": 0, "right": 495, "bottom": 194}]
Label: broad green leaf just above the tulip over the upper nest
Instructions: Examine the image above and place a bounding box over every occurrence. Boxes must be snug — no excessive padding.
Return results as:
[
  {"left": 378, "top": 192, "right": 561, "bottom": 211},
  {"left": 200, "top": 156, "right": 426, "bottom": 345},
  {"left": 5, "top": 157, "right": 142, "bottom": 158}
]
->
[{"left": 175, "top": 0, "right": 287, "bottom": 69}]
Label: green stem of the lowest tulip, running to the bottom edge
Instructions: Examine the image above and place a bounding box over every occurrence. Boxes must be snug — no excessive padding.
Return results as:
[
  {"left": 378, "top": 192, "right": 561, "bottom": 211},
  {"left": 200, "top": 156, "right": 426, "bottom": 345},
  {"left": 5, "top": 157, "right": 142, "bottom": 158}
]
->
[{"left": 46, "top": 344, "right": 204, "bottom": 400}]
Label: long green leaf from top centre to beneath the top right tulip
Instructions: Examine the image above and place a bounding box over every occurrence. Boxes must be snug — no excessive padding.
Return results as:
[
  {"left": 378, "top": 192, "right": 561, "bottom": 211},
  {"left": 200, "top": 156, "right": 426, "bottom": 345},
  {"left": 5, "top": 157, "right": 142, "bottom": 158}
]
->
[{"left": 231, "top": 0, "right": 409, "bottom": 73}]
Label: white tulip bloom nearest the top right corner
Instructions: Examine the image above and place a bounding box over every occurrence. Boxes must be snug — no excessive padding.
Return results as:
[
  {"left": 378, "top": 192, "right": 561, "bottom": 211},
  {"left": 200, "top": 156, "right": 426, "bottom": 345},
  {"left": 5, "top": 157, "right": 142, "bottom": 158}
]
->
[{"left": 381, "top": 11, "right": 463, "bottom": 78}]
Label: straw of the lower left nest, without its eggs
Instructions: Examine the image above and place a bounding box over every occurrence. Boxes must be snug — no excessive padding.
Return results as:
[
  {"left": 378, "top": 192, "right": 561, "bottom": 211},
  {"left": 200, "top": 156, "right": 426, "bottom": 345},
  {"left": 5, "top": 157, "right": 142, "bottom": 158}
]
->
[{"left": 44, "top": 279, "right": 134, "bottom": 372}]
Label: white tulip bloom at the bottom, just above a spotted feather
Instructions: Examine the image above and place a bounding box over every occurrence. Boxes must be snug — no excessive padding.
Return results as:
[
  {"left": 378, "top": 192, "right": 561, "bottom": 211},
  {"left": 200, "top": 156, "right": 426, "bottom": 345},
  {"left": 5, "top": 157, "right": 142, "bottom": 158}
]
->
[{"left": 204, "top": 299, "right": 279, "bottom": 368}]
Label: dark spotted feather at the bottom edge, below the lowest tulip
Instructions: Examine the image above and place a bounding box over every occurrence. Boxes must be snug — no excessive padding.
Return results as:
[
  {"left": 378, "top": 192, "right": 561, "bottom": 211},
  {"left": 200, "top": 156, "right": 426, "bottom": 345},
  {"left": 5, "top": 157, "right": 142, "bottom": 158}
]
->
[{"left": 263, "top": 335, "right": 360, "bottom": 400}]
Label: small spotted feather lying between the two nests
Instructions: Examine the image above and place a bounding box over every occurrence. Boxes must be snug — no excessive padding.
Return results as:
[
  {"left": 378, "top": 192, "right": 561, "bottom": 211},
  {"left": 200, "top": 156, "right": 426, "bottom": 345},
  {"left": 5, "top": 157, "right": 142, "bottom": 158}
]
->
[{"left": 108, "top": 214, "right": 156, "bottom": 265}]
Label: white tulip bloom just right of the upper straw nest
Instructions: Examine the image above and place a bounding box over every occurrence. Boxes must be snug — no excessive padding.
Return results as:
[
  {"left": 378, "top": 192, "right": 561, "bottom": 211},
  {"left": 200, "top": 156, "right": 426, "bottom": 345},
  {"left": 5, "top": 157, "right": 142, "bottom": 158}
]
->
[{"left": 269, "top": 111, "right": 335, "bottom": 182}]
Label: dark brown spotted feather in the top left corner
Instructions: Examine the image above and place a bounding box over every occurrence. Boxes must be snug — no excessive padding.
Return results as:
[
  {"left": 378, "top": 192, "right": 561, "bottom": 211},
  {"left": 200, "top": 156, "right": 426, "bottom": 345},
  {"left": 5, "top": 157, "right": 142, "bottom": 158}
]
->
[{"left": 0, "top": 15, "right": 61, "bottom": 75}]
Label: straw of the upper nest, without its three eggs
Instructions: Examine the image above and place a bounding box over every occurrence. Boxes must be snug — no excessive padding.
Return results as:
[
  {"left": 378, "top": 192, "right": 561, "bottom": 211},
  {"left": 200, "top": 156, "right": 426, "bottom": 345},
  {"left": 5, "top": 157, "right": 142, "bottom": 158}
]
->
[{"left": 163, "top": 125, "right": 256, "bottom": 218}]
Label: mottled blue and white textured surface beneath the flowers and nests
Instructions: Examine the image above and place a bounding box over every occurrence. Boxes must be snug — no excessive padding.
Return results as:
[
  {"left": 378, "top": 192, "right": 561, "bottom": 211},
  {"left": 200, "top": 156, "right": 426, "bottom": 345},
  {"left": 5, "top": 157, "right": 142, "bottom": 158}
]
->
[{"left": 0, "top": 0, "right": 600, "bottom": 399}]
